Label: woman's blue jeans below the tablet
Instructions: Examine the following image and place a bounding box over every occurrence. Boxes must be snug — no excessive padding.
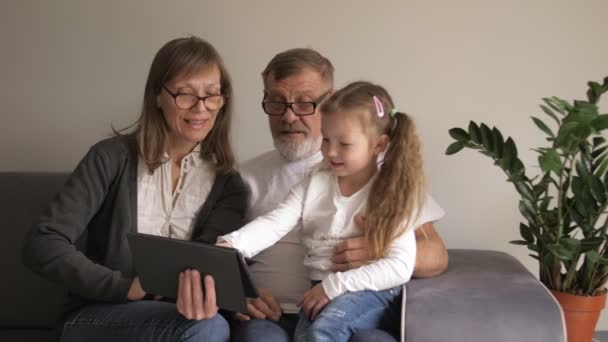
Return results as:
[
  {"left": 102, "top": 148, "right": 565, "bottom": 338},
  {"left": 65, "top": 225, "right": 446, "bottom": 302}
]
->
[{"left": 61, "top": 300, "right": 230, "bottom": 342}]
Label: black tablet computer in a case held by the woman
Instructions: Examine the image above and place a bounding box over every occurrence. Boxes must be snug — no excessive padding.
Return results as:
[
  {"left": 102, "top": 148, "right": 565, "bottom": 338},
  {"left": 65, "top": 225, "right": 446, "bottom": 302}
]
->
[{"left": 127, "top": 233, "right": 258, "bottom": 312}]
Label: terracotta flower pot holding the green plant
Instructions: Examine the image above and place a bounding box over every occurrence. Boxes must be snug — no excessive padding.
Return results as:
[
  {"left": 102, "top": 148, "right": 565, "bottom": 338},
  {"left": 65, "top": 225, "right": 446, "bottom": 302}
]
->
[{"left": 551, "top": 290, "right": 606, "bottom": 342}]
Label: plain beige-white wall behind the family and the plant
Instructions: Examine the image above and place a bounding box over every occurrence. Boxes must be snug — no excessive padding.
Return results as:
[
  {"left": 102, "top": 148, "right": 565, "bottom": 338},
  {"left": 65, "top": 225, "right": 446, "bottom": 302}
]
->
[{"left": 0, "top": 0, "right": 608, "bottom": 329}]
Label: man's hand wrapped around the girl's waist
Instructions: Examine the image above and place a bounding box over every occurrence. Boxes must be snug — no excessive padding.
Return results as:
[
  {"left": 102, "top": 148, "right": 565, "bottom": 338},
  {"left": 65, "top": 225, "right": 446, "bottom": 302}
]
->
[{"left": 331, "top": 214, "right": 372, "bottom": 272}]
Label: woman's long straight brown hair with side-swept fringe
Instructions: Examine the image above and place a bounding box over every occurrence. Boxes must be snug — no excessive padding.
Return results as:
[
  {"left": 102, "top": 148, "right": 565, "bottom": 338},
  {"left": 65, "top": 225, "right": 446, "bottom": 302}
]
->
[{"left": 116, "top": 37, "right": 235, "bottom": 173}]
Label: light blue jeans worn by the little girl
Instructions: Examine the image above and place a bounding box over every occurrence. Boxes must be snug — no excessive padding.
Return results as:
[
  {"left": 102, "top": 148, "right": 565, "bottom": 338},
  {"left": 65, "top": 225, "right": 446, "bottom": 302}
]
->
[{"left": 294, "top": 286, "right": 401, "bottom": 342}]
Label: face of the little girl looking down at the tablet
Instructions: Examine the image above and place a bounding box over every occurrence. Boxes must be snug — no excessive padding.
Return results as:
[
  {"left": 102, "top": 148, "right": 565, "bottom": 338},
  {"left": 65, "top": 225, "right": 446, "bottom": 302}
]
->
[{"left": 321, "top": 113, "right": 388, "bottom": 182}]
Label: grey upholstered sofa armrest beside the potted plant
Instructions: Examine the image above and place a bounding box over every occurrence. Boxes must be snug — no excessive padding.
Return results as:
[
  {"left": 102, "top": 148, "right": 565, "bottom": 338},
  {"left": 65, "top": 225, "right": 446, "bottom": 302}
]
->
[{"left": 403, "top": 250, "right": 565, "bottom": 342}]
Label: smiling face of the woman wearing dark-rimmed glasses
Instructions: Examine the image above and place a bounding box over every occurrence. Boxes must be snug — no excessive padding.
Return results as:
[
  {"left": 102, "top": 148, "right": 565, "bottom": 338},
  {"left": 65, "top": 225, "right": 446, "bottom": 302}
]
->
[{"left": 156, "top": 65, "right": 221, "bottom": 154}]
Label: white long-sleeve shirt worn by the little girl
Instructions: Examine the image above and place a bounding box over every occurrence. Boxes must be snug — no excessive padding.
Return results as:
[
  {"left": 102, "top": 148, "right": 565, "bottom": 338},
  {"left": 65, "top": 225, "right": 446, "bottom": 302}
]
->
[{"left": 219, "top": 169, "right": 444, "bottom": 299}]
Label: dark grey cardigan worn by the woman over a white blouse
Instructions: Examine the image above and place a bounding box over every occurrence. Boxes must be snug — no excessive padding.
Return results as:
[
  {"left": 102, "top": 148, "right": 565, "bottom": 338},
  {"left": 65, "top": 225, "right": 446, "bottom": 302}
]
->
[{"left": 23, "top": 136, "right": 248, "bottom": 311}]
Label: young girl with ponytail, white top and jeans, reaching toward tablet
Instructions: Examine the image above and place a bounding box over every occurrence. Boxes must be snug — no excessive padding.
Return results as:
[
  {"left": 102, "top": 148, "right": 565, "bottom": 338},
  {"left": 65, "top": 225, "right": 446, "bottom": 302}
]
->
[{"left": 219, "top": 82, "right": 443, "bottom": 341}]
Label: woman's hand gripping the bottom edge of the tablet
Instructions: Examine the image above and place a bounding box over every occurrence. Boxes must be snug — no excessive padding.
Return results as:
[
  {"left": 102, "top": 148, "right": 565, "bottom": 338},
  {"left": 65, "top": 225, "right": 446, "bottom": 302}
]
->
[{"left": 177, "top": 270, "right": 218, "bottom": 320}]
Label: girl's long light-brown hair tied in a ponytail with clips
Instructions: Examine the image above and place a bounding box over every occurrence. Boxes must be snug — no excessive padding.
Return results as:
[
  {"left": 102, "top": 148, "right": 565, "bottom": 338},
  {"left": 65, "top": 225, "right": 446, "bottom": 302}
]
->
[{"left": 321, "top": 81, "right": 426, "bottom": 259}]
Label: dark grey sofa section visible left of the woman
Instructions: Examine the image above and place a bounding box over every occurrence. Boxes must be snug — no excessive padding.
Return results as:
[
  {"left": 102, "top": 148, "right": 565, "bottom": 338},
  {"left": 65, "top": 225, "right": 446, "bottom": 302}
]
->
[{"left": 0, "top": 172, "right": 68, "bottom": 328}]
